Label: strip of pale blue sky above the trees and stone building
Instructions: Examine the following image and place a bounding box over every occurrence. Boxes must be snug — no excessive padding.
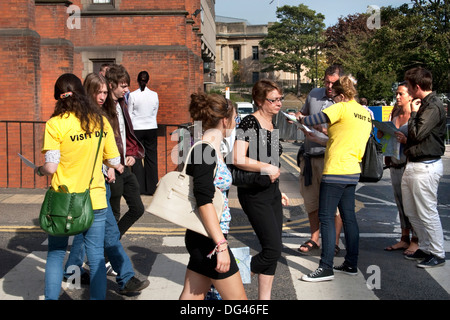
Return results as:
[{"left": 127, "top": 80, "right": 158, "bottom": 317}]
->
[{"left": 216, "top": 0, "right": 411, "bottom": 27}]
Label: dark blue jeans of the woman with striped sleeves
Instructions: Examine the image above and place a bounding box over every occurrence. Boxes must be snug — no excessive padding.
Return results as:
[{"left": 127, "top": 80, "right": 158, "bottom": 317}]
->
[{"left": 319, "top": 181, "right": 359, "bottom": 269}]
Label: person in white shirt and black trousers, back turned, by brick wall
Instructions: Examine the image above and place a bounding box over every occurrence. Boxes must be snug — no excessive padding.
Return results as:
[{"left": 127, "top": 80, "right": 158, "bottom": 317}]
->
[{"left": 128, "top": 71, "right": 159, "bottom": 195}]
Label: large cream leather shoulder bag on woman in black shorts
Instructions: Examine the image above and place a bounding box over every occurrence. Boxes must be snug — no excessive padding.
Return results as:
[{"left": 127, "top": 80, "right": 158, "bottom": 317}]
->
[{"left": 146, "top": 141, "right": 224, "bottom": 237}]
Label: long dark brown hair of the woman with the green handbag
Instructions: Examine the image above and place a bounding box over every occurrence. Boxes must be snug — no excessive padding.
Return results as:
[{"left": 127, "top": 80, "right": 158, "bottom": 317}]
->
[{"left": 52, "top": 73, "right": 103, "bottom": 133}]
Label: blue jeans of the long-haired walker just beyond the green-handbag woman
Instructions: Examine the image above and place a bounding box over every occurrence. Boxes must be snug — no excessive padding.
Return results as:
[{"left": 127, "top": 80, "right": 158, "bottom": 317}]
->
[{"left": 65, "top": 183, "right": 134, "bottom": 289}]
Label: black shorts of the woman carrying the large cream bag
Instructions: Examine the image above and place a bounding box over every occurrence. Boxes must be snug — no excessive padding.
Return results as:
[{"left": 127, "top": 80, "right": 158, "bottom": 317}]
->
[{"left": 184, "top": 230, "right": 239, "bottom": 280}]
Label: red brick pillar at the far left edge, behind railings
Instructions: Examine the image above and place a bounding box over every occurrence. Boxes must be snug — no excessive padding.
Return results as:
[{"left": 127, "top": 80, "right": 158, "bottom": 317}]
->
[{"left": 0, "top": 0, "right": 40, "bottom": 187}]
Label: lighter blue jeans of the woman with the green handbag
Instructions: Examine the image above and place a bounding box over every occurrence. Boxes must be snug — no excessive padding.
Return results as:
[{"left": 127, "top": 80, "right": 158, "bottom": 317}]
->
[{"left": 45, "top": 209, "right": 107, "bottom": 300}]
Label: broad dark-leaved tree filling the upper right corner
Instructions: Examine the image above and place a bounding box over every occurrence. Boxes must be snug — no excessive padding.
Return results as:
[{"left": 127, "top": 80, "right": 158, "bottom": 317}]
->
[{"left": 323, "top": 0, "right": 450, "bottom": 102}]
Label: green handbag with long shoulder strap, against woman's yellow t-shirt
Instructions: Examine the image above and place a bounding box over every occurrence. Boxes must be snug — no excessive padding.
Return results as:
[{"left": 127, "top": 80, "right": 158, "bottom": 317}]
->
[{"left": 39, "top": 130, "right": 103, "bottom": 236}]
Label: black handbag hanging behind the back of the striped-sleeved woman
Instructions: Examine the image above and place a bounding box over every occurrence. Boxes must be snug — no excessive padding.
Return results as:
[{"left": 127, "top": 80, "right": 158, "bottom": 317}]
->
[{"left": 359, "top": 129, "right": 383, "bottom": 182}]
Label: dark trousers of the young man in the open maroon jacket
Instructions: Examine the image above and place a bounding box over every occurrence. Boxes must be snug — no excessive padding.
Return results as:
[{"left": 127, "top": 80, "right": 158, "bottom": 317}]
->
[{"left": 110, "top": 167, "right": 145, "bottom": 237}]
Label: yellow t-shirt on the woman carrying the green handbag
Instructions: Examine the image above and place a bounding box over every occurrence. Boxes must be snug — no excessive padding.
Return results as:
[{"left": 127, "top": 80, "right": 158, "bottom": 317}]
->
[{"left": 42, "top": 113, "right": 120, "bottom": 210}]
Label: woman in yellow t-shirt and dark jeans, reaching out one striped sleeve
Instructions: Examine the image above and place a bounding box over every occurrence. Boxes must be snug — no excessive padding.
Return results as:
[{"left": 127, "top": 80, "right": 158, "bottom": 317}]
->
[{"left": 300, "top": 76, "right": 372, "bottom": 282}]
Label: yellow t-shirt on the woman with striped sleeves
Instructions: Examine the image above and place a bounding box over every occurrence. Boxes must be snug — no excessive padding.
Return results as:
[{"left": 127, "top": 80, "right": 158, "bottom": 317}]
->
[{"left": 323, "top": 100, "right": 372, "bottom": 175}]
